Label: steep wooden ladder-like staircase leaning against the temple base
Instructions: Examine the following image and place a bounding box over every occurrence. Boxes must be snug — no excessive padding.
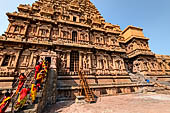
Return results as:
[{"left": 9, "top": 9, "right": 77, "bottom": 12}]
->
[{"left": 79, "top": 71, "right": 95, "bottom": 103}]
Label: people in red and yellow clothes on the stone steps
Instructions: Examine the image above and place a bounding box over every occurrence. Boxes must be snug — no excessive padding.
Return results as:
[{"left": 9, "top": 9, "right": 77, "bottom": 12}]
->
[{"left": 0, "top": 59, "right": 50, "bottom": 113}]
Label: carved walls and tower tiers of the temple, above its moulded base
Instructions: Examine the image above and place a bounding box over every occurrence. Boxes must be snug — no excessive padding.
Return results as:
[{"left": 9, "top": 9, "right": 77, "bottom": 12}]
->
[{"left": 0, "top": 0, "right": 170, "bottom": 91}]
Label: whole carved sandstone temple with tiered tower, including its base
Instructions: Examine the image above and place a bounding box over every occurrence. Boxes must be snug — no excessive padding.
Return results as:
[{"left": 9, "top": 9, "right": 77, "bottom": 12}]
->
[{"left": 0, "top": 0, "right": 170, "bottom": 99}]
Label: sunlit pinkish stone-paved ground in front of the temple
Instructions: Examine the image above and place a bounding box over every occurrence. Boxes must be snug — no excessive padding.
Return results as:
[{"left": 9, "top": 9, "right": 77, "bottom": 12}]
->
[{"left": 44, "top": 93, "right": 170, "bottom": 113}]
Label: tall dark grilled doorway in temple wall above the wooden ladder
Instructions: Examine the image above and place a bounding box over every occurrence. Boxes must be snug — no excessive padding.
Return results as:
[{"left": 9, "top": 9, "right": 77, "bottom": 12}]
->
[{"left": 70, "top": 51, "right": 79, "bottom": 72}]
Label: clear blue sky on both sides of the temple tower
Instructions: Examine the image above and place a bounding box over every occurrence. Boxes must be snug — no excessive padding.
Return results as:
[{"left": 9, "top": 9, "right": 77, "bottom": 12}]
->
[{"left": 0, "top": 0, "right": 170, "bottom": 55}]
